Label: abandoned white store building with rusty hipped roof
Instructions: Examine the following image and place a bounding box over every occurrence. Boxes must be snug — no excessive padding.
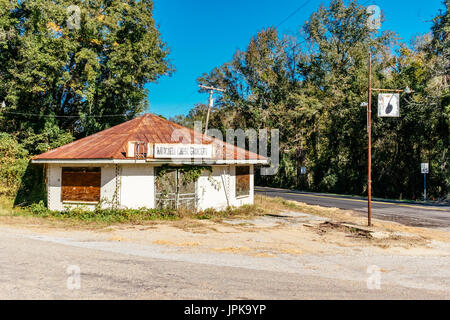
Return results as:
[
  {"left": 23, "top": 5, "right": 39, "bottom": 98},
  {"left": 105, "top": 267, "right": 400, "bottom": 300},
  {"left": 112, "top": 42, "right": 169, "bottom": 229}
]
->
[{"left": 32, "top": 114, "right": 269, "bottom": 210}]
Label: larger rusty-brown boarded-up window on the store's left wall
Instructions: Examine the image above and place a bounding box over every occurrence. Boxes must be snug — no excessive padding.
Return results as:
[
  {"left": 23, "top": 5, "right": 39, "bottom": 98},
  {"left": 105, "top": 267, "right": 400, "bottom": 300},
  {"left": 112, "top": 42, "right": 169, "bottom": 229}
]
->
[{"left": 61, "top": 167, "right": 101, "bottom": 202}]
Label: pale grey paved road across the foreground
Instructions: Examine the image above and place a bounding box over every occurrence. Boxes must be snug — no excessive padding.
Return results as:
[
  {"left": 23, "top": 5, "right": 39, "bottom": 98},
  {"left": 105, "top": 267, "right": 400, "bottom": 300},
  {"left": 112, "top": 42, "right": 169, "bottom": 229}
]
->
[{"left": 0, "top": 228, "right": 449, "bottom": 299}]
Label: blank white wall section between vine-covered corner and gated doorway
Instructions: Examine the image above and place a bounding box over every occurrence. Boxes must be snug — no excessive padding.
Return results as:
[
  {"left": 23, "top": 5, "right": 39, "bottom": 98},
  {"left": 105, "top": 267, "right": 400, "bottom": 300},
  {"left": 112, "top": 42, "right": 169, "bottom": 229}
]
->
[{"left": 120, "top": 164, "right": 155, "bottom": 209}]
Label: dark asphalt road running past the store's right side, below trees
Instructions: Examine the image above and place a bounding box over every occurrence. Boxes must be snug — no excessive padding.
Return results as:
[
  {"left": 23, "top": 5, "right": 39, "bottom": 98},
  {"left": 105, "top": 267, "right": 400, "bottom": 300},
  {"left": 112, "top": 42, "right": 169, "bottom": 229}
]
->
[{"left": 255, "top": 187, "right": 450, "bottom": 231}]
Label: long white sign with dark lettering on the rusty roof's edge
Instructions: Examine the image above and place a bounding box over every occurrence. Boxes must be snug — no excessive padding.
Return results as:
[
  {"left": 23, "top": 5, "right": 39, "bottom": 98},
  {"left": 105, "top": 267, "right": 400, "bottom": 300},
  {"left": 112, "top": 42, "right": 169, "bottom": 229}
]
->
[{"left": 154, "top": 143, "right": 212, "bottom": 159}]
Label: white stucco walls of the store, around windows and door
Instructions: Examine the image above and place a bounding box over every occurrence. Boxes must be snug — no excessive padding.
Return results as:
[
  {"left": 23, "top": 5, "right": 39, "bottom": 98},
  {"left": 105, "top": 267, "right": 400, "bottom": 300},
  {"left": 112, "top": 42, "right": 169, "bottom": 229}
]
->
[{"left": 47, "top": 164, "right": 254, "bottom": 211}]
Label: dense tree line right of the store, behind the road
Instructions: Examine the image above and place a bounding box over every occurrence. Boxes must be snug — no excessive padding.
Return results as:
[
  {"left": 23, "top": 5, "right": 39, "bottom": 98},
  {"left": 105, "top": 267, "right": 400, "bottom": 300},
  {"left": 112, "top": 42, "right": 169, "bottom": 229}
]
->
[{"left": 174, "top": 0, "right": 450, "bottom": 199}]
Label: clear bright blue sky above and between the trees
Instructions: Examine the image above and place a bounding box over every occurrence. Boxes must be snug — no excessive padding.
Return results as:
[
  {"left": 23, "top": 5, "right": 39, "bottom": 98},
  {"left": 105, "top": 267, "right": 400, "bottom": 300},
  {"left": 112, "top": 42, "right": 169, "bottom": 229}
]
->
[{"left": 147, "top": 0, "right": 443, "bottom": 118}]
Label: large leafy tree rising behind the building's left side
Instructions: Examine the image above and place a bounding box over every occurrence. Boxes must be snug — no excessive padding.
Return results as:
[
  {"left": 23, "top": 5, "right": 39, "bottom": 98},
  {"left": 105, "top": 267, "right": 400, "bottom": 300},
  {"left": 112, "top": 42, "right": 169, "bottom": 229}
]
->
[{"left": 0, "top": 0, "right": 172, "bottom": 146}]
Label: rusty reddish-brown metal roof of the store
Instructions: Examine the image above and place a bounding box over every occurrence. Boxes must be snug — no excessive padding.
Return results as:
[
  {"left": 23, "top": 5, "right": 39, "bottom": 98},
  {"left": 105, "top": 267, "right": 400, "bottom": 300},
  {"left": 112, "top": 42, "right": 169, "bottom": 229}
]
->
[{"left": 33, "top": 113, "right": 267, "bottom": 160}]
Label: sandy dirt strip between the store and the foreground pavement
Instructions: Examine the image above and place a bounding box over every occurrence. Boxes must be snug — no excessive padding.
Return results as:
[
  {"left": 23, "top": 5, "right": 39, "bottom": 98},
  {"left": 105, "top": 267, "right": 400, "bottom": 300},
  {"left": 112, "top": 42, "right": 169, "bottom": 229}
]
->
[{"left": 0, "top": 196, "right": 450, "bottom": 257}]
